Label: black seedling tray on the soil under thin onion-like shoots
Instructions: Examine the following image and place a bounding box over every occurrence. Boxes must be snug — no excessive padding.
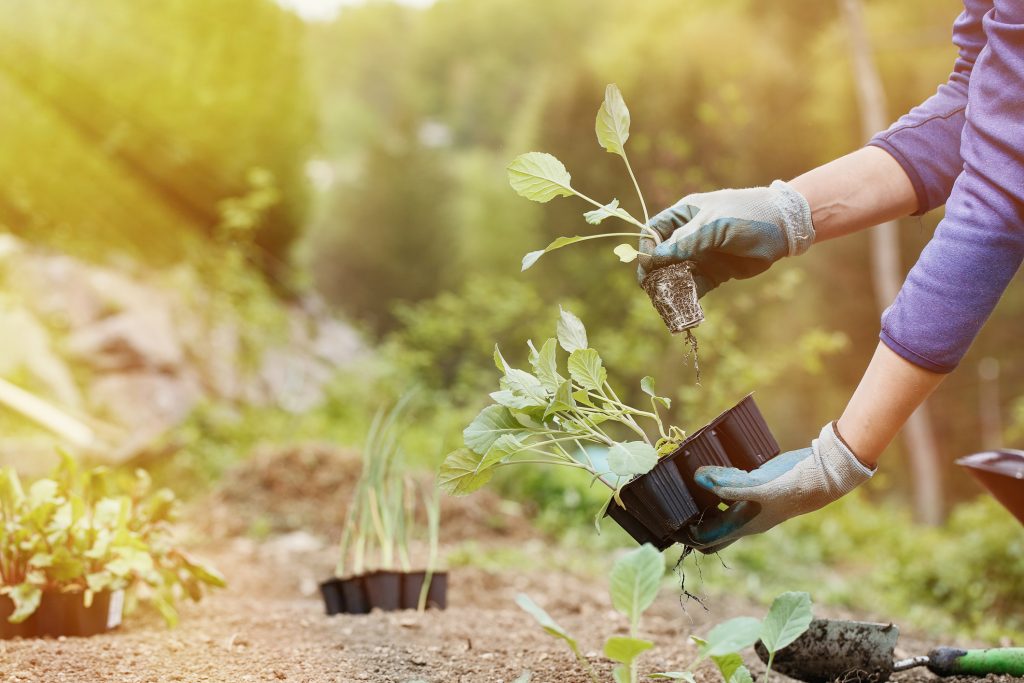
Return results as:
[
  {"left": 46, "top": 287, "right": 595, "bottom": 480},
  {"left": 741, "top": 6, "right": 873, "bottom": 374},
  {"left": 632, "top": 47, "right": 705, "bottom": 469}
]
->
[{"left": 319, "top": 571, "right": 447, "bottom": 616}]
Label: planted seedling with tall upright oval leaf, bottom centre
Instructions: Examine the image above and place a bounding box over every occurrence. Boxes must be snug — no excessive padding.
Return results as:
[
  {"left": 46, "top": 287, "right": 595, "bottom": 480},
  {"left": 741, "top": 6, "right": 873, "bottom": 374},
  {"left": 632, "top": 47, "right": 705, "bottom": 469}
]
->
[{"left": 516, "top": 544, "right": 665, "bottom": 683}]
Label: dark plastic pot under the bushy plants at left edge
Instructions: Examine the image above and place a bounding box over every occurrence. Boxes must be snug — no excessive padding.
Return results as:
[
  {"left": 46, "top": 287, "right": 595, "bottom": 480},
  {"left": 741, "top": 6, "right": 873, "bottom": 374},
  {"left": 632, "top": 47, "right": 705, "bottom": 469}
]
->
[{"left": 0, "top": 591, "right": 124, "bottom": 639}]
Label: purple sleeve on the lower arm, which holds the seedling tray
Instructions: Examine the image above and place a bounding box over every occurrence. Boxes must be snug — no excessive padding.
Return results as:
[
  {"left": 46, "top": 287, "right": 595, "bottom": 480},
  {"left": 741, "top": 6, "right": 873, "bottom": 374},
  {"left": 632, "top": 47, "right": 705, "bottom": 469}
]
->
[{"left": 882, "top": 0, "right": 1024, "bottom": 373}]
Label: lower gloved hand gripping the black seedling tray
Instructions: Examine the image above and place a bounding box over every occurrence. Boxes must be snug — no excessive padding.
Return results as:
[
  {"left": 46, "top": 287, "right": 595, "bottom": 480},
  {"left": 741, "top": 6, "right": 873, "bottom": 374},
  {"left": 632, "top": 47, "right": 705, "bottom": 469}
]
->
[{"left": 683, "top": 423, "right": 874, "bottom": 552}]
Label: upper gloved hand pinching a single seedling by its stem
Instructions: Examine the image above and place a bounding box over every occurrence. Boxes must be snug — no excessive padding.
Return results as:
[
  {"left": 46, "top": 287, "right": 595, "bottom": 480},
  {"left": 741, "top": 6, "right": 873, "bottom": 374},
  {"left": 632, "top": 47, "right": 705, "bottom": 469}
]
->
[{"left": 637, "top": 180, "right": 814, "bottom": 297}]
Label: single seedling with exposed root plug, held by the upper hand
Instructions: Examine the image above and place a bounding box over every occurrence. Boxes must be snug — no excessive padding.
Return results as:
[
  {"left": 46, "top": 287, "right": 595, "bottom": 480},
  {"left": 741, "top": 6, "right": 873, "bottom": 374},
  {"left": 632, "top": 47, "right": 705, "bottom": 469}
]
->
[{"left": 508, "top": 83, "right": 703, "bottom": 335}]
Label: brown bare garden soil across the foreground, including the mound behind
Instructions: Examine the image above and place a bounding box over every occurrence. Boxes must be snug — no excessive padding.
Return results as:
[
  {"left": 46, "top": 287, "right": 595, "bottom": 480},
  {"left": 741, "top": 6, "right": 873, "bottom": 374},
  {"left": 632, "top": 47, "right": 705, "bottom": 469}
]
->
[{"left": 0, "top": 446, "right": 1012, "bottom": 683}]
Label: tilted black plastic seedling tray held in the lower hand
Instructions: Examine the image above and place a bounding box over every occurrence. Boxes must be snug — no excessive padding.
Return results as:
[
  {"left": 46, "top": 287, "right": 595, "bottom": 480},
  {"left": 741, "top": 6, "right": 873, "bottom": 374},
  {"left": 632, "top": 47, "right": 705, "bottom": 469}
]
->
[{"left": 606, "top": 395, "right": 779, "bottom": 550}]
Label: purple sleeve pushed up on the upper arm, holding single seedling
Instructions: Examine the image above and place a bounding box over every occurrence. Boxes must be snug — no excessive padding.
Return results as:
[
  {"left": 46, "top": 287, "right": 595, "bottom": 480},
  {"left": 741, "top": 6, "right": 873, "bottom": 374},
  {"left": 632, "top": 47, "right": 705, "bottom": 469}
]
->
[{"left": 868, "top": 0, "right": 992, "bottom": 216}]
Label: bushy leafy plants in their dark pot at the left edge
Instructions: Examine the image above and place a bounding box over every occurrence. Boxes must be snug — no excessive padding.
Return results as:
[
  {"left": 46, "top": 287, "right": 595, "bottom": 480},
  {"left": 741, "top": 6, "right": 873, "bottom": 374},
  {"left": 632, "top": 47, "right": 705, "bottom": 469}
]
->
[{"left": 0, "top": 454, "right": 224, "bottom": 638}]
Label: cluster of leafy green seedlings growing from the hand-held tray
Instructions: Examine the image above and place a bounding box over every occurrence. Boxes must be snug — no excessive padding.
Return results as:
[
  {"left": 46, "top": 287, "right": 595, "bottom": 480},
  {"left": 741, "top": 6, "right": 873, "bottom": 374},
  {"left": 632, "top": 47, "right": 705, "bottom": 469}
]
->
[{"left": 438, "top": 309, "right": 685, "bottom": 521}]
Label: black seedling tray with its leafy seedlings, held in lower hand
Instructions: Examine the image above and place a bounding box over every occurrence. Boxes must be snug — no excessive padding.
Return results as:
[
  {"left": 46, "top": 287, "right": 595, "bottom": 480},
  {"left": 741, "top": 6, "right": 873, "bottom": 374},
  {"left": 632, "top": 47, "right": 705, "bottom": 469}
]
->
[{"left": 439, "top": 309, "right": 779, "bottom": 549}]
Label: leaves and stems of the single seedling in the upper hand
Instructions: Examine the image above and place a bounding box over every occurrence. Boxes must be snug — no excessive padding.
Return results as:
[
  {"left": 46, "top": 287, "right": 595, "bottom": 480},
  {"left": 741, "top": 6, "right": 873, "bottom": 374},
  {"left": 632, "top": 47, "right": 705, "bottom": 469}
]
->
[{"left": 508, "top": 84, "right": 660, "bottom": 270}]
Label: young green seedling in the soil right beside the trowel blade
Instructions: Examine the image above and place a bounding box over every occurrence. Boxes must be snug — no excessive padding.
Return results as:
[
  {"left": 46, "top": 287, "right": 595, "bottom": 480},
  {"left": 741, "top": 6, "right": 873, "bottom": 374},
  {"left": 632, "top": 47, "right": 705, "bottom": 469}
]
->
[{"left": 651, "top": 592, "right": 812, "bottom": 683}]
